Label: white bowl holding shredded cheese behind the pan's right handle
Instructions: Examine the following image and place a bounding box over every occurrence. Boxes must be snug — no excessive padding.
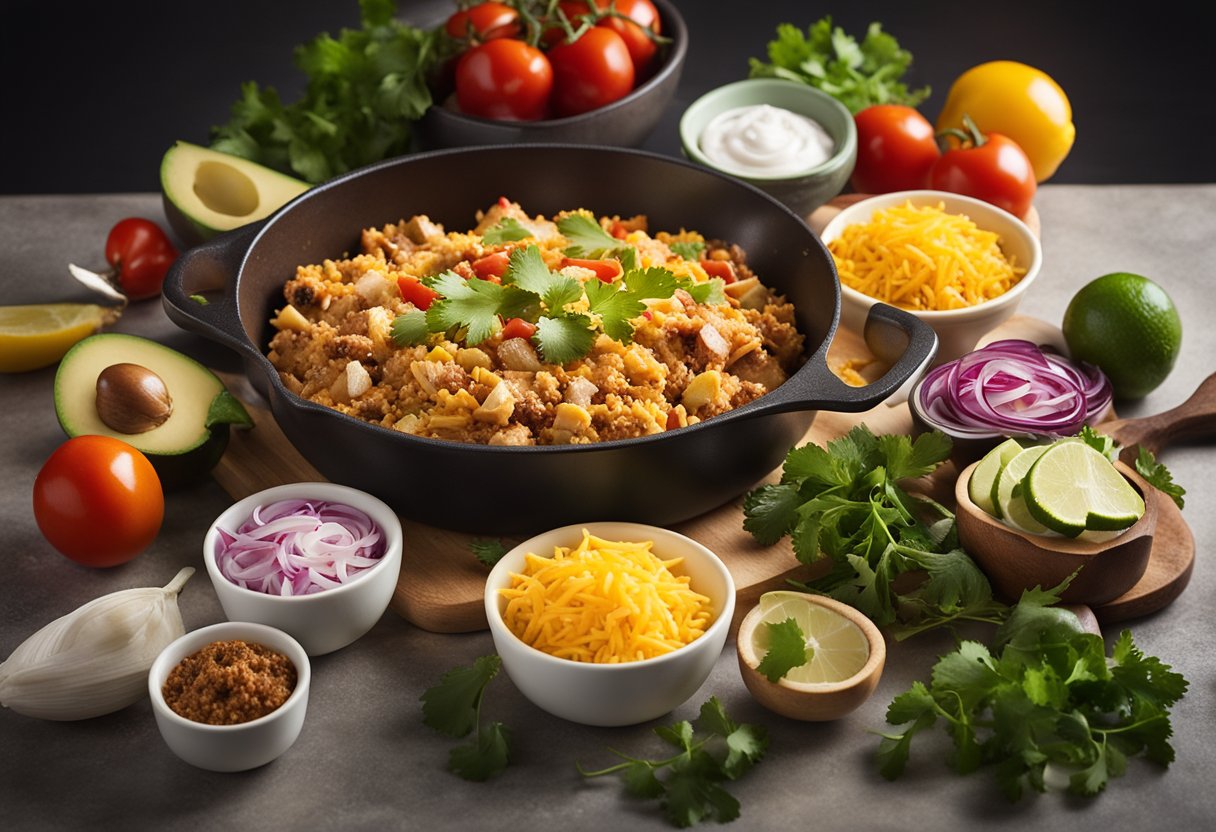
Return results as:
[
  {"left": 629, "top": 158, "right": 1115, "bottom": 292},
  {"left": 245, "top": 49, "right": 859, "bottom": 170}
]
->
[{"left": 820, "top": 191, "right": 1043, "bottom": 364}]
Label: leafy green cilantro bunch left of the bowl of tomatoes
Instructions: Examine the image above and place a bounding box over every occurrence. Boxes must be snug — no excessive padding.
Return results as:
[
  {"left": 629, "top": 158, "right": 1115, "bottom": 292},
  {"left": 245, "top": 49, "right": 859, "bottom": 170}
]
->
[{"left": 212, "top": 0, "right": 438, "bottom": 182}]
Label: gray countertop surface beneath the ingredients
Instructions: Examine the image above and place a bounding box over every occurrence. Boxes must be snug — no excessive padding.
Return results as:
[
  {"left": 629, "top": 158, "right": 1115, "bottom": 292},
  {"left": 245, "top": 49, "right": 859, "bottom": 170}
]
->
[{"left": 0, "top": 185, "right": 1216, "bottom": 832}]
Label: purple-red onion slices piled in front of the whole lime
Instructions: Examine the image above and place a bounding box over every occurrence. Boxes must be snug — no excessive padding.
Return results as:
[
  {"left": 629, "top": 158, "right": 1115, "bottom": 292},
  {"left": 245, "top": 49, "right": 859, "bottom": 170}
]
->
[{"left": 917, "top": 338, "right": 1111, "bottom": 437}]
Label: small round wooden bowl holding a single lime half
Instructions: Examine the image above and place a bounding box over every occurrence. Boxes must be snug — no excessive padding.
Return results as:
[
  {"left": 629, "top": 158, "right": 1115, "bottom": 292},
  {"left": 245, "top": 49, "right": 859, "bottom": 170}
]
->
[{"left": 736, "top": 595, "right": 886, "bottom": 721}]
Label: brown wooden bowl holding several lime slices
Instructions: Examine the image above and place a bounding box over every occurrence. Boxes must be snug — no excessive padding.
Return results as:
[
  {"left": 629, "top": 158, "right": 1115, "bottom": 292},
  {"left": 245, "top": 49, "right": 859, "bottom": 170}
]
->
[{"left": 955, "top": 462, "right": 1156, "bottom": 606}]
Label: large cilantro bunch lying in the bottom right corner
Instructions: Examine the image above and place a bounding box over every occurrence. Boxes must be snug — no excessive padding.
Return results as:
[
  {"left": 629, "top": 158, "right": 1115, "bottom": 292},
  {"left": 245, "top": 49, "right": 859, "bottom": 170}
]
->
[{"left": 878, "top": 581, "right": 1187, "bottom": 800}]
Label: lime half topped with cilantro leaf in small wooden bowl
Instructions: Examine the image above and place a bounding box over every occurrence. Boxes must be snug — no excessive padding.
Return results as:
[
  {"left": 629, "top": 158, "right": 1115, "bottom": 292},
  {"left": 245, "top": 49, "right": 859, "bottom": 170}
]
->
[{"left": 745, "top": 590, "right": 869, "bottom": 688}]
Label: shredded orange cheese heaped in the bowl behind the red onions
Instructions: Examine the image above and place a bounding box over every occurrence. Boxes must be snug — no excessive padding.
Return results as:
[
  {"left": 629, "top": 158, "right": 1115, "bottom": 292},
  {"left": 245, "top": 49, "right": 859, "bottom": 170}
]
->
[{"left": 828, "top": 202, "right": 1026, "bottom": 311}]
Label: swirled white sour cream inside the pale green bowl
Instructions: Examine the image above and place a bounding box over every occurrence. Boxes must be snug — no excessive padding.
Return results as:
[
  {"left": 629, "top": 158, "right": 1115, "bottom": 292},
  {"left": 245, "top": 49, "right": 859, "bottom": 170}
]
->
[{"left": 699, "top": 105, "right": 835, "bottom": 176}]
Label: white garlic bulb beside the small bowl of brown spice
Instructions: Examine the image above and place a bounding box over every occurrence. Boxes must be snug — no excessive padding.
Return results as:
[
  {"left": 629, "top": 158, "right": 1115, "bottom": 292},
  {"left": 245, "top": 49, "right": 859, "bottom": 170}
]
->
[{"left": 0, "top": 567, "right": 195, "bottom": 720}]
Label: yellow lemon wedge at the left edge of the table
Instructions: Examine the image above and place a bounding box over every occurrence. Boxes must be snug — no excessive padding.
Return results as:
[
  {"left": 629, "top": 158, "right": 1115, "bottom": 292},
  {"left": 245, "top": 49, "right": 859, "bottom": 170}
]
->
[{"left": 0, "top": 303, "right": 120, "bottom": 372}]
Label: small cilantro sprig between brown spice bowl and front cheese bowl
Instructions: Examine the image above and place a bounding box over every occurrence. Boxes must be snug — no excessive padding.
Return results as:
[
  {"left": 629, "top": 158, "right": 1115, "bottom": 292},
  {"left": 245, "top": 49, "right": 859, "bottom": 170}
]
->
[{"left": 421, "top": 654, "right": 511, "bottom": 781}]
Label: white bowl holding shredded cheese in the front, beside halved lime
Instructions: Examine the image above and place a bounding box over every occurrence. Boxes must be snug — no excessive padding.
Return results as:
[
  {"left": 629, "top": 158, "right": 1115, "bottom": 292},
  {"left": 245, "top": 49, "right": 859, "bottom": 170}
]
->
[{"left": 485, "top": 523, "right": 734, "bottom": 726}]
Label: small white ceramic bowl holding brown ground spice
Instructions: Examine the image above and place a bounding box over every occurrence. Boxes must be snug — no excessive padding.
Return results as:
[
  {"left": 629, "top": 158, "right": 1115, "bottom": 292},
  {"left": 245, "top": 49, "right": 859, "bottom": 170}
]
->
[{"left": 148, "top": 622, "right": 313, "bottom": 771}]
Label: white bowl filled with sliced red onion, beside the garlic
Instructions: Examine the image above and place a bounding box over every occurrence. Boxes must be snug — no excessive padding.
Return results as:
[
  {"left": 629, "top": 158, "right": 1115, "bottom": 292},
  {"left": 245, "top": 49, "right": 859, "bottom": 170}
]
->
[{"left": 203, "top": 483, "right": 401, "bottom": 656}]
